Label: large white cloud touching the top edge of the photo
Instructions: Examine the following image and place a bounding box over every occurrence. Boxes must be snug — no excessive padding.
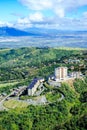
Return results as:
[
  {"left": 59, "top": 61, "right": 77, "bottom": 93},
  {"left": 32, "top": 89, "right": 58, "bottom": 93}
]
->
[{"left": 19, "top": 0, "right": 87, "bottom": 17}]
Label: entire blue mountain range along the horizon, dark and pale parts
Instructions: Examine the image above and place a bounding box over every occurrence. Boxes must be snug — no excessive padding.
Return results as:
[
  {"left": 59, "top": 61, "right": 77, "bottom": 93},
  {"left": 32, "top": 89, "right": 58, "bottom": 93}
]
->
[{"left": 0, "top": 26, "right": 87, "bottom": 38}]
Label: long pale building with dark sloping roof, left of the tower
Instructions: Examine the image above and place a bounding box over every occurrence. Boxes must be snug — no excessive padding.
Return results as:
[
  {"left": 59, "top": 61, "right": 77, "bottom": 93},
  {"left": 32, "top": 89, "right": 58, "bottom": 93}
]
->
[{"left": 27, "top": 78, "right": 44, "bottom": 96}]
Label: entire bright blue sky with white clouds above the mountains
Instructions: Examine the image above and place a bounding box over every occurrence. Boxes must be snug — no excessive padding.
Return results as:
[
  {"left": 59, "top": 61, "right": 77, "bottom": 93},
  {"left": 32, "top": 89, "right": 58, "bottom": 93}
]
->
[{"left": 0, "top": 0, "right": 87, "bottom": 30}]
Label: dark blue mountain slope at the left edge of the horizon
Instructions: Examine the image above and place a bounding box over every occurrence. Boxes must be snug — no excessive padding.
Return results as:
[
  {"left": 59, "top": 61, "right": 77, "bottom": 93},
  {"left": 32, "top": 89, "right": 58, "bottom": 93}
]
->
[{"left": 0, "top": 27, "right": 38, "bottom": 36}]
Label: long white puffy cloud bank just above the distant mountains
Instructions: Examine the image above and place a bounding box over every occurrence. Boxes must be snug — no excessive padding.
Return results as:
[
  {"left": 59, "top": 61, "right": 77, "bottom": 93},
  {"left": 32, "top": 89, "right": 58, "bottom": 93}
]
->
[{"left": 14, "top": 12, "right": 87, "bottom": 30}]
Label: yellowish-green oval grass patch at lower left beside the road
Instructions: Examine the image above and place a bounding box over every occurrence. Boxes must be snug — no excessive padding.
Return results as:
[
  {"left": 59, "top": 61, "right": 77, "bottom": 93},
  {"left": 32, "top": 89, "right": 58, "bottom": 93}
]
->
[{"left": 3, "top": 99, "right": 29, "bottom": 109}]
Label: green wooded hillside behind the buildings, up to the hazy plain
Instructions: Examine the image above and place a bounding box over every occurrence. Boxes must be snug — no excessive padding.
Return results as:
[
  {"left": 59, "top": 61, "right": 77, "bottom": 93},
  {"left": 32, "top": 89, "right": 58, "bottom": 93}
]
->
[{"left": 0, "top": 48, "right": 87, "bottom": 91}]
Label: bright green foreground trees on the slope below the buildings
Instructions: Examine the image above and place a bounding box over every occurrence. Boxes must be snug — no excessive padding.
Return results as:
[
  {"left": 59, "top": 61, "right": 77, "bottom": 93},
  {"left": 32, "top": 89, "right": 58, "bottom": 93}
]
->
[{"left": 0, "top": 78, "right": 87, "bottom": 130}]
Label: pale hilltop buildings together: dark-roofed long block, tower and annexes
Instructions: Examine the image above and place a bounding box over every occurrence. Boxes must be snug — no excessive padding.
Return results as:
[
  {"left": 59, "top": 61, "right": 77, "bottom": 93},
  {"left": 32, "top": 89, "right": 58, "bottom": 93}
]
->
[{"left": 27, "top": 67, "right": 82, "bottom": 96}]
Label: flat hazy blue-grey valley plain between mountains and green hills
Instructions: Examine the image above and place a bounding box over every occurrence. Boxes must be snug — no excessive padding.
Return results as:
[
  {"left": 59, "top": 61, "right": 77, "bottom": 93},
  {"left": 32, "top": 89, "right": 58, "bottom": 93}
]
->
[{"left": 0, "top": 30, "right": 87, "bottom": 48}]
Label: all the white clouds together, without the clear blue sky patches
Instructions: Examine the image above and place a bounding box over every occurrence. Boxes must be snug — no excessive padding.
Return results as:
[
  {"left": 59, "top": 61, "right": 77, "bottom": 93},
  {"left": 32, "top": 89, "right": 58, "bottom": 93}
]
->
[{"left": 0, "top": 0, "right": 87, "bottom": 29}]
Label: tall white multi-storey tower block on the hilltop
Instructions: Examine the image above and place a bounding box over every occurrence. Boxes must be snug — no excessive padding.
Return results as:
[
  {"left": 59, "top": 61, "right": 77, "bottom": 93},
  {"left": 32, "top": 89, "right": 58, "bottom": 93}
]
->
[{"left": 55, "top": 67, "right": 67, "bottom": 80}]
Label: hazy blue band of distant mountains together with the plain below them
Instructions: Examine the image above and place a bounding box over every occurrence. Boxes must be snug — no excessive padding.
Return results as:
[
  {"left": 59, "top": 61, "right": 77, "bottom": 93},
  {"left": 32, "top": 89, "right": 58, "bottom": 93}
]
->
[{"left": 0, "top": 27, "right": 87, "bottom": 48}]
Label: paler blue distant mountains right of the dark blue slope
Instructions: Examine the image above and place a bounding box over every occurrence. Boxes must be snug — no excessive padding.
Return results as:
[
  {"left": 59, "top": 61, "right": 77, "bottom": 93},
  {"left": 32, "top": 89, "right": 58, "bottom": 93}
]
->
[{"left": 24, "top": 27, "right": 87, "bottom": 36}]
